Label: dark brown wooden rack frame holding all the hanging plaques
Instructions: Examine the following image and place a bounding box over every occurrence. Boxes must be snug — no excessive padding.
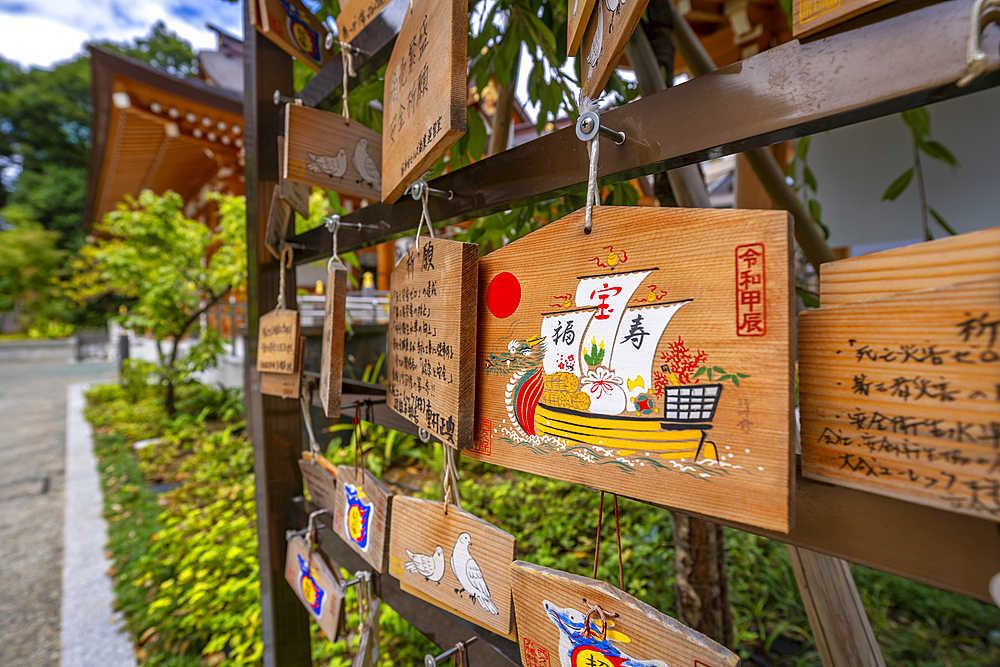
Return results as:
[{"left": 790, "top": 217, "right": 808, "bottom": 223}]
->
[{"left": 244, "top": 0, "right": 1000, "bottom": 667}]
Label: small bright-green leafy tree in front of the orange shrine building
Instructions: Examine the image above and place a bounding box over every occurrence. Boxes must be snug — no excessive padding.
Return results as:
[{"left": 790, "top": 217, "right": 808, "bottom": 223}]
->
[{"left": 74, "top": 190, "right": 246, "bottom": 415}]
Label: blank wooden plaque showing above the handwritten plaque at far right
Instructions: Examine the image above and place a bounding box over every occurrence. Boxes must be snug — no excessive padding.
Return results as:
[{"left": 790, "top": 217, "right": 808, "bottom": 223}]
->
[{"left": 819, "top": 227, "right": 1000, "bottom": 308}]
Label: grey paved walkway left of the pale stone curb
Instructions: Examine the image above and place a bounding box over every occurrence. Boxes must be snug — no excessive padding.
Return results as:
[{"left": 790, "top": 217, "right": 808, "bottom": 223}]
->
[{"left": 0, "top": 363, "right": 114, "bottom": 667}]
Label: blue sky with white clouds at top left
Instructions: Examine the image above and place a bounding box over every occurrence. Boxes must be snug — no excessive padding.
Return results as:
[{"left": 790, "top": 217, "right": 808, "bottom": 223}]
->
[{"left": 0, "top": 0, "right": 243, "bottom": 67}]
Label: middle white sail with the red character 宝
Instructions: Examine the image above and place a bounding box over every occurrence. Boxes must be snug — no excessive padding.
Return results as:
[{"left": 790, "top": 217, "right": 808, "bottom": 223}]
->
[{"left": 575, "top": 271, "right": 650, "bottom": 371}]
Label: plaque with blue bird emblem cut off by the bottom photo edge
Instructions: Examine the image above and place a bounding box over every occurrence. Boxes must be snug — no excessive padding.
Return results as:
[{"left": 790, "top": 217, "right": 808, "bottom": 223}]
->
[{"left": 510, "top": 560, "right": 740, "bottom": 667}]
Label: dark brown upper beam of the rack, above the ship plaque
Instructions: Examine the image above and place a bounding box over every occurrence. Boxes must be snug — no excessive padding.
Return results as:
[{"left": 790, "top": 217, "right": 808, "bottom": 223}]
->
[{"left": 286, "top": 0, "right": 1000, "bottom": 263}]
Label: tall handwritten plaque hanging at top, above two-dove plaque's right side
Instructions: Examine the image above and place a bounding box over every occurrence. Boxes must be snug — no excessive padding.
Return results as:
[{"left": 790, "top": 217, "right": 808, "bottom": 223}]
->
[{"left": 382, "top": 0, "right": 469, "bottom": 204}]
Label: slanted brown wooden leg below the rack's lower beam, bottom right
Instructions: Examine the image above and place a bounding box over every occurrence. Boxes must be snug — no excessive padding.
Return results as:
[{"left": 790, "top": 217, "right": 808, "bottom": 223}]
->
[{"left": 786, "top": 544, "right": 885, "bottom": 667}]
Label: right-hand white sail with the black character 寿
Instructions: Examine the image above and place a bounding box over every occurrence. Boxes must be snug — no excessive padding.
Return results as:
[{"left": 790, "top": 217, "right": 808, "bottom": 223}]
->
[{"left": 608, "top": 299, "right": 691, "bottom": 406}]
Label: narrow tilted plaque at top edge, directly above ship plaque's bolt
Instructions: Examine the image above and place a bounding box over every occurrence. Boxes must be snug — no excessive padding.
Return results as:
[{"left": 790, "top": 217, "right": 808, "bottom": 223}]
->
[{"left": 570, "top": 0, "right": 649, "bottom": 97}]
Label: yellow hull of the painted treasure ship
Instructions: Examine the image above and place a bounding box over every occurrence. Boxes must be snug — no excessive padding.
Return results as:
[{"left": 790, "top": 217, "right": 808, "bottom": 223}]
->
[{"left": 535, "top": 403, "right": 717, "bottom": 459}]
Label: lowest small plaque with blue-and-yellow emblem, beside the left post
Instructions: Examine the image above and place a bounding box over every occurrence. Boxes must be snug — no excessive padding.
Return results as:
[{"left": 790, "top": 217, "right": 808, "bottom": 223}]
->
[{"left": 285, "top": 536, "right": 345, "bottom": 642}]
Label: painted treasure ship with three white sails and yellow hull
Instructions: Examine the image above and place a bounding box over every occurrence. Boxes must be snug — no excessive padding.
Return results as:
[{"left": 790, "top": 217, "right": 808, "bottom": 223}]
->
[{"left": 496, "top": 269, "right": 722, "bottom": 461}]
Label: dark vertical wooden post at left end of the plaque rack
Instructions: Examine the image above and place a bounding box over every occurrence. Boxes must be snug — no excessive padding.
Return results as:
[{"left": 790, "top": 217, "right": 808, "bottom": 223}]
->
[{"left": 243, "top": 2, "right": 312, "bottom": 667}]
